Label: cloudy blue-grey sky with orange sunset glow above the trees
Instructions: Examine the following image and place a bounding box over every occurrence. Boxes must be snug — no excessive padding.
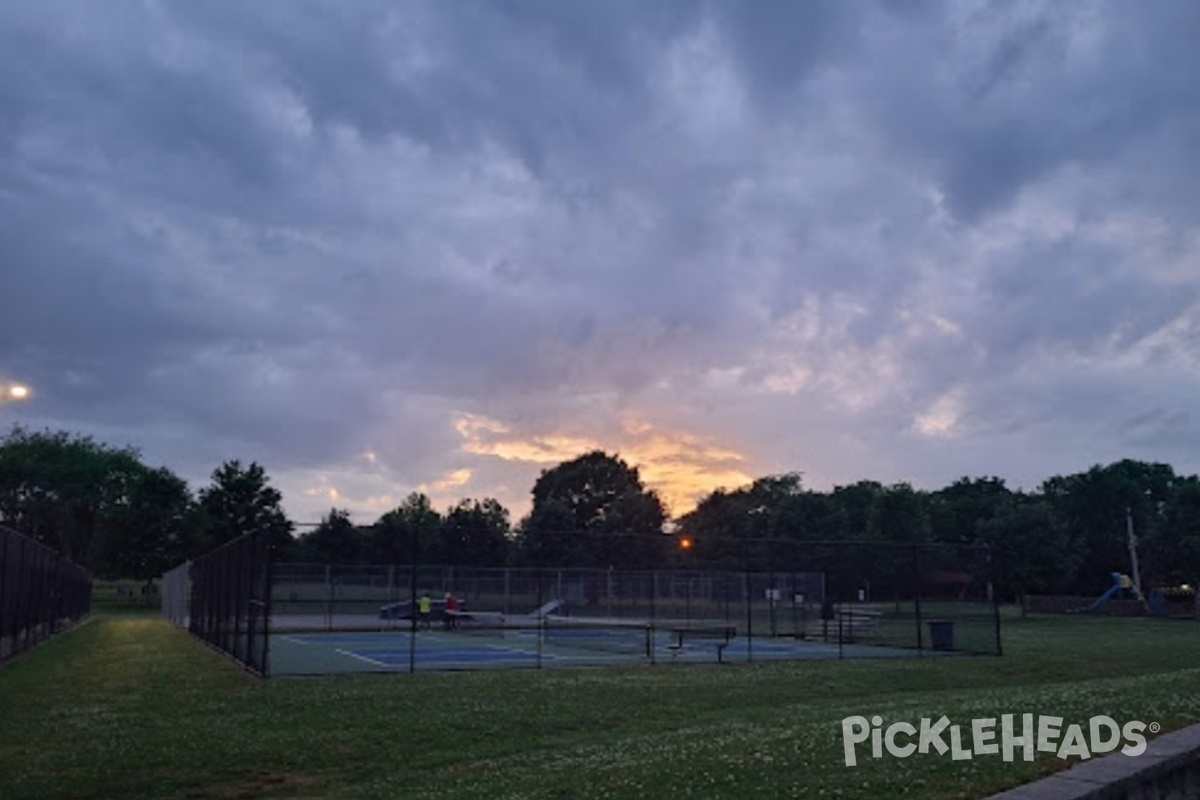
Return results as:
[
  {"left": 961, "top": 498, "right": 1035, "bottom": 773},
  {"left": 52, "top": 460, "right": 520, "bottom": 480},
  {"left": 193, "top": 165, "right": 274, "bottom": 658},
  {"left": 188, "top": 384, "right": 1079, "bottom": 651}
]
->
[{"left": 0, "top": 0, "right": 1200, "bottom": 523}]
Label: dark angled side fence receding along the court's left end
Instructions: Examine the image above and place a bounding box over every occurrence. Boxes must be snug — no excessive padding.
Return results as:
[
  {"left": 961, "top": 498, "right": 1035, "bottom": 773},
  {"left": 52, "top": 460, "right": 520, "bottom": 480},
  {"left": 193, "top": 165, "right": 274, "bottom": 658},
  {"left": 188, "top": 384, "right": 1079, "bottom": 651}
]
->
[{"left": 187, "top": 534, "right": 271, "bottom": 675}]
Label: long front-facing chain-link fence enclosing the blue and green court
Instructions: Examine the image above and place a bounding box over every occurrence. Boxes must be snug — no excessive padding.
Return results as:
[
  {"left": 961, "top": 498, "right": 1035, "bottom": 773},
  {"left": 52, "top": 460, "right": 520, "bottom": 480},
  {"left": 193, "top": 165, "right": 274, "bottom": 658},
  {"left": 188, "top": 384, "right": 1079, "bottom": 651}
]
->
[{"left": 270, "top": 542, "right": 1001, "bottom": 674}]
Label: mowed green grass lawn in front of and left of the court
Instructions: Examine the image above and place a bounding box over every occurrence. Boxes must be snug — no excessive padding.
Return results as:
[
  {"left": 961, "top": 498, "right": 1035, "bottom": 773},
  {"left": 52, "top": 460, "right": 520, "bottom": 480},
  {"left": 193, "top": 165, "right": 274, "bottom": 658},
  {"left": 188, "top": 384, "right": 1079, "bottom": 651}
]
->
[{"left": 0, "top": 613, "right": 1200, "bottom": 800}]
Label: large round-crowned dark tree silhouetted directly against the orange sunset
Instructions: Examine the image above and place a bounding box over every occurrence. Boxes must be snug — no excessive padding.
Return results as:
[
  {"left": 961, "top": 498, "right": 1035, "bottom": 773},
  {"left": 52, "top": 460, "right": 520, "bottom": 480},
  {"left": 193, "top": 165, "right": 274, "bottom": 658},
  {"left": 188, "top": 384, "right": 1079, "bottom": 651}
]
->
[{"left": 518, "top": 450, "right": 670, "bottom": 567}]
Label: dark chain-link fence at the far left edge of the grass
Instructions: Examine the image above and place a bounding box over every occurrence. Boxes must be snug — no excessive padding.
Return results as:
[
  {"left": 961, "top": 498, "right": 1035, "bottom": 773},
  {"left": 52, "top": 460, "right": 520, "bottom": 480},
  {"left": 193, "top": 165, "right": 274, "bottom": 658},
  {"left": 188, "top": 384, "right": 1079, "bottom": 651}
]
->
[{"left": 0, "top": 525, "right": 91, "bottom": 661}]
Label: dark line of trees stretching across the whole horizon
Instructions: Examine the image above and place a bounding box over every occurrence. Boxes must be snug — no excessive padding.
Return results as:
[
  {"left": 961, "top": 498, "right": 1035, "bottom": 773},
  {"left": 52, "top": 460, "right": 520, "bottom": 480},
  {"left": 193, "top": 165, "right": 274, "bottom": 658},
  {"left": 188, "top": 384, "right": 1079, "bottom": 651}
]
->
[{"left": 0, "top": 427, "right": 1200, "bottom": 596}]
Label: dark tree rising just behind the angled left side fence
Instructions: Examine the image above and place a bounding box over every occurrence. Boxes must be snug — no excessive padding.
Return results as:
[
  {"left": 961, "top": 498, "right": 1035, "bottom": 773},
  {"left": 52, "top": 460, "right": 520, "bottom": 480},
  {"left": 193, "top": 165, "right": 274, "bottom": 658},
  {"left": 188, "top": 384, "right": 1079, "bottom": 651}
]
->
[{"left": 199, "top": 461, "right": 292, "bottom": 558}]
